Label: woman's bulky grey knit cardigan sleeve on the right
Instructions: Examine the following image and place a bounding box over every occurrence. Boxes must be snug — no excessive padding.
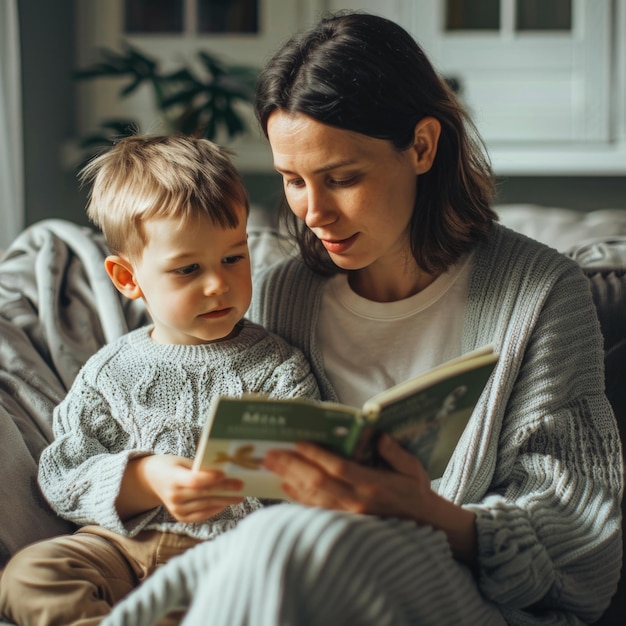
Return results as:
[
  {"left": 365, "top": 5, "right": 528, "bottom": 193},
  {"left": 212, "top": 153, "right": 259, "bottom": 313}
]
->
[{"left": 468, "top": 267, "right": 622, "bottom": 622}]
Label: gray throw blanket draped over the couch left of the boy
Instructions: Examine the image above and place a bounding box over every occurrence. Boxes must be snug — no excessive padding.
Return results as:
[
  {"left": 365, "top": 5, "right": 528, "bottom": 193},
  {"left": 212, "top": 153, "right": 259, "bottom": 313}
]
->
[{"left": 0, "top": 220, "right": 149, "bottom": 568}]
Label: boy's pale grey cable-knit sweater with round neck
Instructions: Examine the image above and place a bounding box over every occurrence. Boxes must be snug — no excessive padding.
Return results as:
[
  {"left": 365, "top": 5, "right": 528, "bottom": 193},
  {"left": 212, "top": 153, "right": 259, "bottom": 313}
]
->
[{"left": 39, "top": 321, "right": 319, "bottom": 539}]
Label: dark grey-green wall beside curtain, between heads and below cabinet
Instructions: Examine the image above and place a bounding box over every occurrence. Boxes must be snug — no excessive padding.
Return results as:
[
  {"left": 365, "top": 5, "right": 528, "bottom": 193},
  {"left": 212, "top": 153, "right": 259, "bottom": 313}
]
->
[{"left": 19, "top": 0, "right": 626, "bottom": 233}]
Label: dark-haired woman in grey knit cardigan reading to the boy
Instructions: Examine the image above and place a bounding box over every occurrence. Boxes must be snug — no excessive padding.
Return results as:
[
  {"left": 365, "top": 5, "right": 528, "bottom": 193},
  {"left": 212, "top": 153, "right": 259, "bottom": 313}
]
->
[{"left": 102, "top": 13, "right": 622, "bottom": 624}]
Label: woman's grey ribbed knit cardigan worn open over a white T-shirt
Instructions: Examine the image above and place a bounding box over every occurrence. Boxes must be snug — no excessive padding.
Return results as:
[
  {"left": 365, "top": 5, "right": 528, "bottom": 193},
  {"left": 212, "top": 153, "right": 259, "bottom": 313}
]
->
[{"left": 250, "top": 224, "right": 623, "bottom": 624}]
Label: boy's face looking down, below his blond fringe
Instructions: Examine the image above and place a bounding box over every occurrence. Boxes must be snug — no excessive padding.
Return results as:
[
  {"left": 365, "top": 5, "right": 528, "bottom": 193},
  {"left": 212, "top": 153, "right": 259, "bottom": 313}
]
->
[{"left": 133, "top": 208, "right": 252, "bottom": 344}]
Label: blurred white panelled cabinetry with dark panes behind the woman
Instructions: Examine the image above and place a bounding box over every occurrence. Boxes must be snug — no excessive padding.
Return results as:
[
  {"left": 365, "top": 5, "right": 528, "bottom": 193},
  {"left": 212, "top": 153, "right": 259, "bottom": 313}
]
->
[{"left": 76, "top": 0, "right": 626, "bottom": 174}]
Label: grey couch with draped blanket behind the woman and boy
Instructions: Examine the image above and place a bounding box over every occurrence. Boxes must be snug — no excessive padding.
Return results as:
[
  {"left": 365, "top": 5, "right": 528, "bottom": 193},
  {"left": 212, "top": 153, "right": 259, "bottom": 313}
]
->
[{"left": 0, "top": 205, "right": 626, "bottom": 626}]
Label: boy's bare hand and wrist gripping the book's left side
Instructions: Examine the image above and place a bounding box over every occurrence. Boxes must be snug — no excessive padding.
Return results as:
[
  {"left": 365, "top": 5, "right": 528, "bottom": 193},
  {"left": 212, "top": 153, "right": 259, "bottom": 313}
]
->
[{"left": 116, "top": 454, "right": 243, "bottom": 523}]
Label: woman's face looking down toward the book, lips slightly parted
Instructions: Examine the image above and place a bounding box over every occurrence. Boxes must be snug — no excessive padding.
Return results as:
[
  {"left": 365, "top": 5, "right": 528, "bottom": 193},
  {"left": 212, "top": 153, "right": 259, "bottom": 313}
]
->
[{"left": 267, "top": 110, "right": 422, "bottom": 272}]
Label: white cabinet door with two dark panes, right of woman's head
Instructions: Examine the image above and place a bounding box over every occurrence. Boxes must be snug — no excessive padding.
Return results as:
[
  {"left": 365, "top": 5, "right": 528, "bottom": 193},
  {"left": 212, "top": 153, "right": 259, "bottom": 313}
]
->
[{"left": 413, "top": 0, "right": 612, "bottom": 146}]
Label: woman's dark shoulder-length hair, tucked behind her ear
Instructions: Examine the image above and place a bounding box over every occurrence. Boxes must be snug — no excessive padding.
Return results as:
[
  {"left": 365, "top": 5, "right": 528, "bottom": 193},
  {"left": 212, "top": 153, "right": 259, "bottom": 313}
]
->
[{"left": 256, "top": 12, "right": 497, "bottom": 274}]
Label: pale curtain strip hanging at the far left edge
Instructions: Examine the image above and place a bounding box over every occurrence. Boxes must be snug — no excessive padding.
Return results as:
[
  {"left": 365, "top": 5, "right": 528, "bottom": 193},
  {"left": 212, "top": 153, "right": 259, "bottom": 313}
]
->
[{"left": 0, "top": 0, "right": 24, "bottom": 250}]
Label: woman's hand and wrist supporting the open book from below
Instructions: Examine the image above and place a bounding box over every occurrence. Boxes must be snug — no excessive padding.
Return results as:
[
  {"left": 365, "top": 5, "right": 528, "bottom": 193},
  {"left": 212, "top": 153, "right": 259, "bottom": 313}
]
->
[{"left": 264, "top": 435, "right": 476, "bottom": 561}]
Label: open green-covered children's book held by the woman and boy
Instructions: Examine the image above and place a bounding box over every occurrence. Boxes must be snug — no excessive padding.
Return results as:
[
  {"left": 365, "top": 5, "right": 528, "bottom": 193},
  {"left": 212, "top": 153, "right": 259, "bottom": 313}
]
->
[{"left": 193, "top": 346, "right": 498, "bottom": 498}]
